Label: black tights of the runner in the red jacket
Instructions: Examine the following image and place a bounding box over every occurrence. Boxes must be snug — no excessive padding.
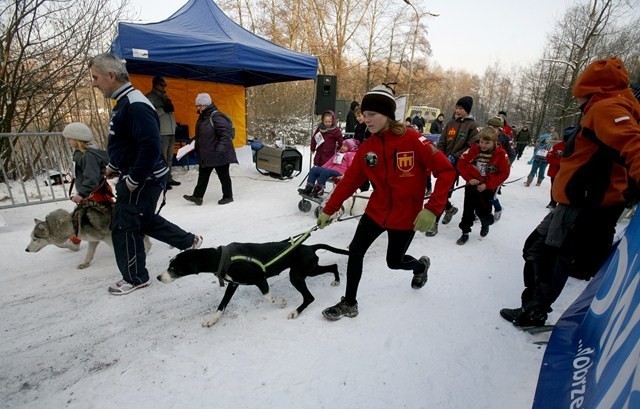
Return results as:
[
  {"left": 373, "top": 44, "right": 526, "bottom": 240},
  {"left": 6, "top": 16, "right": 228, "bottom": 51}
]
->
[{"left": 344, "top": 214, "right": 424, "bottom": 304}]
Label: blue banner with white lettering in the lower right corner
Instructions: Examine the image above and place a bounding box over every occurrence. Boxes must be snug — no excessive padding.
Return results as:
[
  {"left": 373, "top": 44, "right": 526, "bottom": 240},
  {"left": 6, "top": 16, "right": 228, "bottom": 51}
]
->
[{"left": 533, "top": 214, "right": 640, "bottom": 409}]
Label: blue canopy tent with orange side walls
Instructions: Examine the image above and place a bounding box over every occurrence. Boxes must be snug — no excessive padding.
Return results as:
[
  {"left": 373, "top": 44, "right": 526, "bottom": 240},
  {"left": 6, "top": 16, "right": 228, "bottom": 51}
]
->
[{"left": 111, "top": 0, "right": 318, "bottom": 147}]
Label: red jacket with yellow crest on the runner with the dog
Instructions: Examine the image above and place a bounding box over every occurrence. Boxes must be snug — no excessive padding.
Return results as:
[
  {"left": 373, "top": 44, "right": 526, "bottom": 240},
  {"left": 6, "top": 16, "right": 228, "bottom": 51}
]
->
[{"left": 322, "top": 129, "right": 456, "bottom": 230}]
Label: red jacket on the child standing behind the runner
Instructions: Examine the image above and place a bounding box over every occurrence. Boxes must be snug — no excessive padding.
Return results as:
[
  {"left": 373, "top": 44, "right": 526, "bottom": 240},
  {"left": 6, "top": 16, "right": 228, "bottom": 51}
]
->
[{"left": 458, "top": 143, "right": 511, "bottom": 190}]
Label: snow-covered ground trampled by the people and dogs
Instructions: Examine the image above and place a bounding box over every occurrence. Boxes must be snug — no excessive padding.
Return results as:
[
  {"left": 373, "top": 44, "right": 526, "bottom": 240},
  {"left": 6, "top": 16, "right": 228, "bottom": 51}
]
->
[{"left": 0, "top": 147, "right": 608, "bottom": 409}]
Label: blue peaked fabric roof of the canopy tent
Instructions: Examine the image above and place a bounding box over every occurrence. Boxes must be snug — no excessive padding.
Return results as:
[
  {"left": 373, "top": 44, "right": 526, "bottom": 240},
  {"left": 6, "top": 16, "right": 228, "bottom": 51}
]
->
[{"left": 111, "top": 0, "right": 318, "bottom": 87}]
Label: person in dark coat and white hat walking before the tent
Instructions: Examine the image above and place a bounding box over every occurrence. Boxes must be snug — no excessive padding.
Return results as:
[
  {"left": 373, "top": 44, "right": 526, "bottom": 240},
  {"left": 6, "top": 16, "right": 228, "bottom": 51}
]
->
[{"left": 183, "top": 94, "right": 238, "bottom": 205}]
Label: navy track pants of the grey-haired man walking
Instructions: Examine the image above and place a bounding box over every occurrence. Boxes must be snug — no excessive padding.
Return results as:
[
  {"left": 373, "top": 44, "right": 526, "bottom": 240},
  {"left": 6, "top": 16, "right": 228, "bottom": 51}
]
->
[{"left": 111, "top": 180, "right": 193, "bottom": 285}]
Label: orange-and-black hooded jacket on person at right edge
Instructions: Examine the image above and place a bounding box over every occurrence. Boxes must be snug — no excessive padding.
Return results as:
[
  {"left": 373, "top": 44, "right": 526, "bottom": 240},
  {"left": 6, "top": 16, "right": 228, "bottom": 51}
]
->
[{"left": 552, "top": 57, "right": 640, "bottom": 207}]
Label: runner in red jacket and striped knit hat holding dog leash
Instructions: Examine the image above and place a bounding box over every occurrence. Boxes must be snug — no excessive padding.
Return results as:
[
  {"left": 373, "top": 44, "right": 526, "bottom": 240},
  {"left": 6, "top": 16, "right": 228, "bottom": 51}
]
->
[{"left": 318, "top": 85, "right": 456, "bottom": 320}]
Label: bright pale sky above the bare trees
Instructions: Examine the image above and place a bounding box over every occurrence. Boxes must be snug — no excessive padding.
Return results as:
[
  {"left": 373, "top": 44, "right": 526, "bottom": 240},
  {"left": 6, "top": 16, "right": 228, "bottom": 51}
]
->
[{"left": 124, "top": 0, "right": 575, "bottom": 74}]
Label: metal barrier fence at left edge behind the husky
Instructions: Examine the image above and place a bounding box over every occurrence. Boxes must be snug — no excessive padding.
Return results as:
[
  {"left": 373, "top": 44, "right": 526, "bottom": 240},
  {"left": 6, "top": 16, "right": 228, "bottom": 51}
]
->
[{"left": 0, "top": 132, "right": 73, "bottom": 209}]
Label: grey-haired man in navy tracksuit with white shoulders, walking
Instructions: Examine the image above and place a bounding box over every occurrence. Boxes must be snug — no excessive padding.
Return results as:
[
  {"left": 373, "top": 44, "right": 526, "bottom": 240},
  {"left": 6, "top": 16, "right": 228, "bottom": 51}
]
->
[{"left": 89, "top": 54, "right": 202, "bottom": 295}]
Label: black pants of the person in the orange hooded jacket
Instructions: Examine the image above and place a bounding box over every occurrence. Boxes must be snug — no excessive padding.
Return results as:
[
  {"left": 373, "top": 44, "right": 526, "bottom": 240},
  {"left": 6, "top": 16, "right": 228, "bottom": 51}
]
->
[{"left": 522, "top": 205, "right": 624, "bottom": 312}]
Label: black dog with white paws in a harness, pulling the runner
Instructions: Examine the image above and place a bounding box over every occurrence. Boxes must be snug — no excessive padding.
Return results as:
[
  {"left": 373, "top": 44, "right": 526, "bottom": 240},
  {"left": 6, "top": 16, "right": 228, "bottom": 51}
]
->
[{"left": 158, "top": 241, "right": 349, "bottom": 327}]
